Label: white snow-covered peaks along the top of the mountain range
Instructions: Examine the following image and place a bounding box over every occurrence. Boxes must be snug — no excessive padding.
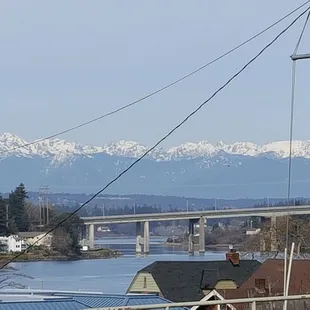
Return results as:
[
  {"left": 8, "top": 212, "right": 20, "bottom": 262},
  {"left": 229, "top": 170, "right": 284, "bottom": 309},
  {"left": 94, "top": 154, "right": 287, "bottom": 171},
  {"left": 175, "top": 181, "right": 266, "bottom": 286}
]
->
[{"left": 0, "top": 133, "right": 310, "bottom": 162}]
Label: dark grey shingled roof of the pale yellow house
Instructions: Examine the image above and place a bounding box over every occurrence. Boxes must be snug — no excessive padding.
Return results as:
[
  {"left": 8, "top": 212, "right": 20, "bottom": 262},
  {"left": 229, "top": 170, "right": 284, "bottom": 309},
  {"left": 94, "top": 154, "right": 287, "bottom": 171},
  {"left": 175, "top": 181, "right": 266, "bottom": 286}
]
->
[{"left": 139, "top": 260, "right": 260, "bottom": 302}]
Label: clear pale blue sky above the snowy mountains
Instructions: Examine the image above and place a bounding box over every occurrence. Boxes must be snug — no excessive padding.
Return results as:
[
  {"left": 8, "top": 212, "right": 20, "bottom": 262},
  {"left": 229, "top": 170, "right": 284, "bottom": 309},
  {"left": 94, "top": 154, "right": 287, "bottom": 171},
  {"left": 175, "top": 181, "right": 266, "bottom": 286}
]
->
[{"left": 0, "top": 0, "right": 310, "bottom": 146}]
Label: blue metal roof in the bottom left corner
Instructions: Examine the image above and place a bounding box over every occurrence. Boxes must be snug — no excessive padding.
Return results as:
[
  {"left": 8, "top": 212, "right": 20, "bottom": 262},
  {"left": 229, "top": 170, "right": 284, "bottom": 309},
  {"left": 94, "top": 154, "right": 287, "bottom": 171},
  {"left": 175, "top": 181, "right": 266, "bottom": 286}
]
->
[{"left": 0, "top": 291, "right": 185, "bottom": 310}]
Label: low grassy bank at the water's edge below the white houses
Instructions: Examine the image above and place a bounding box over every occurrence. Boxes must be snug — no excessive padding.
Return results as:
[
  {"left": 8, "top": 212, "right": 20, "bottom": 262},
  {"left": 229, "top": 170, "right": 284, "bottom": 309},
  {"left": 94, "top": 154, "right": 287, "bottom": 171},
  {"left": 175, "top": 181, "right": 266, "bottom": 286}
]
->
[{"left": 0, "top": 247, "right": 122, "bottom": 262}]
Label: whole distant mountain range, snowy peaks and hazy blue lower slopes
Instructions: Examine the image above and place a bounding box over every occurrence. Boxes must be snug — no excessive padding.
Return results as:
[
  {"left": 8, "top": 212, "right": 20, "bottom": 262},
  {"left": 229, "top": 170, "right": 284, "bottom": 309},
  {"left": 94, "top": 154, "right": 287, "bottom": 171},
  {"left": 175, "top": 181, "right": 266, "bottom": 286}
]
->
[{"left": 0, "top": 133, "right": 310, "bottom": 198}]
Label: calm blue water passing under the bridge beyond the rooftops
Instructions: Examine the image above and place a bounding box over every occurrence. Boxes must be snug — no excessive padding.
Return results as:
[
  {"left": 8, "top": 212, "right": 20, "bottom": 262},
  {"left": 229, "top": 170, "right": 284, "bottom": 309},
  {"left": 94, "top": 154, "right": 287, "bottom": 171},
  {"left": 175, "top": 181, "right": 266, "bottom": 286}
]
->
[{"left": 12, "top": 237, "right": 224, "bottom": 294}]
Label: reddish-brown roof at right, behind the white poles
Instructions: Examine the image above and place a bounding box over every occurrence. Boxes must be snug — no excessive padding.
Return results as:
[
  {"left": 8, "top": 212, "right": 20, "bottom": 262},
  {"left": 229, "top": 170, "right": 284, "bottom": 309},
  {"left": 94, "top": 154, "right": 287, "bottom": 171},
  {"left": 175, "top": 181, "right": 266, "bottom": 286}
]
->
[{"left": 225, "top": 259, "right": 310, "bottom": 298}]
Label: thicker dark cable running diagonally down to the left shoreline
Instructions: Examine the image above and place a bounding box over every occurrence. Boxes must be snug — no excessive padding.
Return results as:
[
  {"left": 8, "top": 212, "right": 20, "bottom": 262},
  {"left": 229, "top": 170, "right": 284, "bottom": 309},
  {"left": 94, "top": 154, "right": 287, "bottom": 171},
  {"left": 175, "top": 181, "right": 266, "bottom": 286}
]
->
[{"left": 0, "top": 7, "right": 310, "bottom": 269}]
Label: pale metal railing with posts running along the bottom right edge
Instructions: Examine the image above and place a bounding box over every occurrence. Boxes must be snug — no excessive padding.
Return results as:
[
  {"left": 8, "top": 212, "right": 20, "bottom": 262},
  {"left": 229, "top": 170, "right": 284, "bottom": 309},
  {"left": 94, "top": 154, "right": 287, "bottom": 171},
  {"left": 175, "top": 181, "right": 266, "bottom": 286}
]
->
[{"left": 91, "top": 294, "right": 310, "bottom": 310}]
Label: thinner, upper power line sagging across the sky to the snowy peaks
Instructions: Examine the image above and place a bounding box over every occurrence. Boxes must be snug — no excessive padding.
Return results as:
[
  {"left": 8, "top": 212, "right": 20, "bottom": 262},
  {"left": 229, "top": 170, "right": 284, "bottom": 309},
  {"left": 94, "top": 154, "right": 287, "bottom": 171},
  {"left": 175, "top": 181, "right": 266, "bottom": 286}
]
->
[{"left": 0, "top": 0, "right": 310, "bottom": 155}]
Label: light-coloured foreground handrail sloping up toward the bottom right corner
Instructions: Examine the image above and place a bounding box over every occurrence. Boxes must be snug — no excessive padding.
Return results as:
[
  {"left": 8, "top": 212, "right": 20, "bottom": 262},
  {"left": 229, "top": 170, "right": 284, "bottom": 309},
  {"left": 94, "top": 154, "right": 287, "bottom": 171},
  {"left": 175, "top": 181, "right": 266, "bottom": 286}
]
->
[{"left": 90, "top": 294, "right": 310, "bottom": 310}]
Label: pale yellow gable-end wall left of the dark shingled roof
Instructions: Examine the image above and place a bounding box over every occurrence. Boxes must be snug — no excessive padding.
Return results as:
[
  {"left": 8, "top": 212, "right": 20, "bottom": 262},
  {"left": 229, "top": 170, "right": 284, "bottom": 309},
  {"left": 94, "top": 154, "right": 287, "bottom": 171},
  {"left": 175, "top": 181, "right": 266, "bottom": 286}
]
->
[{"left": 127, "top": 272, "right": 161, "bottom": 295}]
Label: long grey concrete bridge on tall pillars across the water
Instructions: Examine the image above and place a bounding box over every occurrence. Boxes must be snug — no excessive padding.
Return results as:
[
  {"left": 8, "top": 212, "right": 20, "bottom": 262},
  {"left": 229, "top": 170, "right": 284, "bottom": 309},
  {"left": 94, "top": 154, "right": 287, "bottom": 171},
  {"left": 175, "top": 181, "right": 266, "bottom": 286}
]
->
[{"left": 82, "top": 205, "right": 310, "bottom": 254}]
